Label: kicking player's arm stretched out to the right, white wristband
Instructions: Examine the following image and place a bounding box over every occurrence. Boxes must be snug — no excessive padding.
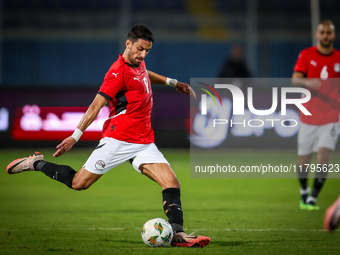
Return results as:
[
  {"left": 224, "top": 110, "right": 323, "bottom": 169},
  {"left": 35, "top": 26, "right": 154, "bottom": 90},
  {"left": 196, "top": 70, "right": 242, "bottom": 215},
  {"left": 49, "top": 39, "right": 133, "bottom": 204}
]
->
[{"left": 148, "top": 71, "right": 196, "bottom": 98}]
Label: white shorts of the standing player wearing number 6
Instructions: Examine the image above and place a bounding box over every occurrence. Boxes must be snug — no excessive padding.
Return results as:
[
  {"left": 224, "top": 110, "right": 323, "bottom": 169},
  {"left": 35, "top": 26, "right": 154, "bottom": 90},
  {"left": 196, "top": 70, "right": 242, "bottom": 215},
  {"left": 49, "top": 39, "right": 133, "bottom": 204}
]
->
[{"left": 298, "top": 122, "right": 339, "bottom": 156}]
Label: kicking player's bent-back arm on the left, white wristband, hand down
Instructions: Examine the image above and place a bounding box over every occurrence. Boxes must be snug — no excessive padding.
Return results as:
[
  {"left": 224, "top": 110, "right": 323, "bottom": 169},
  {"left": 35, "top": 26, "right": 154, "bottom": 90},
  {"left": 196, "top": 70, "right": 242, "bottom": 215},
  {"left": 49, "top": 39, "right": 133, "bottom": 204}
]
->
[{"left": 53, "top": 94, "right": 108, "bottom": 157}]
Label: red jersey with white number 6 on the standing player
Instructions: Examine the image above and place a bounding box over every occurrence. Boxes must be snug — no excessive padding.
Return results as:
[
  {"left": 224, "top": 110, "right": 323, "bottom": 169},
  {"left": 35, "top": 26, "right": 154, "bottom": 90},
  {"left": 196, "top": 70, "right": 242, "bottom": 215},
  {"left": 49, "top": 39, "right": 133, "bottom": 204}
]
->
[{"left": 294, "top": 46, "right": 340, "bottom": 125}]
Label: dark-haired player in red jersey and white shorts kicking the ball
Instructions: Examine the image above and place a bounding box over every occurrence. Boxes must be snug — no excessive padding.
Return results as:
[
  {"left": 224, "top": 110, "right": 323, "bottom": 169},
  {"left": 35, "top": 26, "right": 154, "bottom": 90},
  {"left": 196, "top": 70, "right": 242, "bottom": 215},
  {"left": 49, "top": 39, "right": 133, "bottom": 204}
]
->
[{"left": 7, "top": 24, "right": 210, "bottom": 247}]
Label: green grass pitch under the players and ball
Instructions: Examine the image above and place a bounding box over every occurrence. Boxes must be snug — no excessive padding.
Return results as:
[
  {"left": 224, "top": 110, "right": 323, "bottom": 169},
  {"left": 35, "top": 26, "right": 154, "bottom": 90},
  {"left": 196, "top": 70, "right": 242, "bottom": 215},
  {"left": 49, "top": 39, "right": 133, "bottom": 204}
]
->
[{"left": 0, "top": 148, "right": 340, "bottom": 255}]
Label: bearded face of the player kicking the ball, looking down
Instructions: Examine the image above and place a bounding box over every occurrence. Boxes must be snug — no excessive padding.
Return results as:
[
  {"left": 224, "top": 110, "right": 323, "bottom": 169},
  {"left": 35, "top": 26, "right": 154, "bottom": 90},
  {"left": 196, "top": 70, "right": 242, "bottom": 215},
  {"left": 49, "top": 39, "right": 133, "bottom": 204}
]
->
[{"left": 126, "top": 39, "right": 152, "bottom": 66}]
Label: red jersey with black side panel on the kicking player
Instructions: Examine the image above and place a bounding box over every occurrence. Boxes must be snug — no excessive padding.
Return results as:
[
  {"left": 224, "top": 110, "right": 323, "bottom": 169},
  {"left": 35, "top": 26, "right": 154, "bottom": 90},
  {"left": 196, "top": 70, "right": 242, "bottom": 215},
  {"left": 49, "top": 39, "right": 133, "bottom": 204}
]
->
[{"left": 98, "top": 55, "right": 154, "bottom": 144}]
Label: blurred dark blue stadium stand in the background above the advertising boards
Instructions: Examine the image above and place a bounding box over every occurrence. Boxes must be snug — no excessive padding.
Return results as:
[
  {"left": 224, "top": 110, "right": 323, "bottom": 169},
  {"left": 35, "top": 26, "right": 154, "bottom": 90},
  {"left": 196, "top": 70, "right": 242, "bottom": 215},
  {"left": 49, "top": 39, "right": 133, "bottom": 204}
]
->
[{"left": 2, "top": 0, "right": 340, "bottom": 82}]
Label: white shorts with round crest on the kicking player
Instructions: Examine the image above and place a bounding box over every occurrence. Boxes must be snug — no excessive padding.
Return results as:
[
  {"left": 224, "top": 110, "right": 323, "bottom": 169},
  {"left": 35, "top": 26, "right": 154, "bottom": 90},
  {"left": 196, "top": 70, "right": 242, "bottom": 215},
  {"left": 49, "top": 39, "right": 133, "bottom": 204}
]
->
[{"left": 83, "top": 137, "right": 170, "bottom": 174}]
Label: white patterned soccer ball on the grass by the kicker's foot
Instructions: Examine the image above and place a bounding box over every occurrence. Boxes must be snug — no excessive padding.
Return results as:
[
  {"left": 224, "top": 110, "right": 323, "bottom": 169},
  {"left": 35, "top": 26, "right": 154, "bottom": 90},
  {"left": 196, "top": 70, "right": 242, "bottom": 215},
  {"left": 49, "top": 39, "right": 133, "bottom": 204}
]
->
[{"left": 142, "top": 218, "right": 173, "bottom": 247}]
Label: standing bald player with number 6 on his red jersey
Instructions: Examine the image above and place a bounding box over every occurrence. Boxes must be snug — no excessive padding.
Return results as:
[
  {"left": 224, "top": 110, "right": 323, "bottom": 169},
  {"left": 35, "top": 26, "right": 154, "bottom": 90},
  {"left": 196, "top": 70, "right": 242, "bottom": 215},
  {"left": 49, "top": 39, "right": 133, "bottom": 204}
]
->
[{"left": 292, "top": 20, "right": 340, "bottom": 210}]
